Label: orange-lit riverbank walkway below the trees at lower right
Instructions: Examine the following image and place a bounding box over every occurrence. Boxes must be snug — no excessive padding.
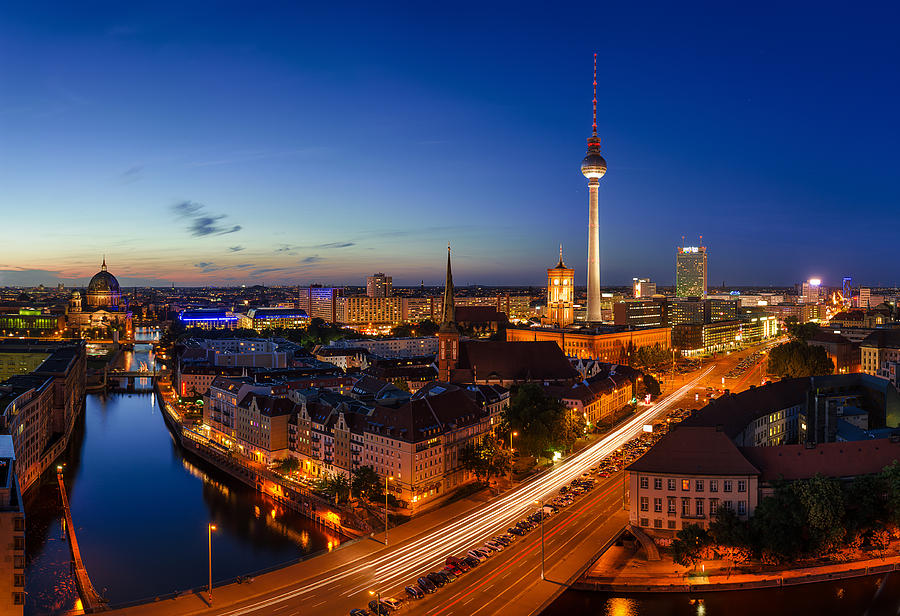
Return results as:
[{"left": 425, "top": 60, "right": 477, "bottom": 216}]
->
[{"left": 573, "top": 546, "right": 900, "bottom": 593}]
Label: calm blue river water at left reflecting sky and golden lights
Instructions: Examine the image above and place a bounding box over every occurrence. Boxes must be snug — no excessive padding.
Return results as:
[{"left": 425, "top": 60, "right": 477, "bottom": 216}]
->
[{"left": 25, "top": 346, "right": 340, "bottom": 614}]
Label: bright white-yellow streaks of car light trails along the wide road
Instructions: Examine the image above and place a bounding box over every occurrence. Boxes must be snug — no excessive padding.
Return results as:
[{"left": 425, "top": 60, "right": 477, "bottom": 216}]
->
[{"left": 219, "top": 364, "right": 716, "bottom": 616}]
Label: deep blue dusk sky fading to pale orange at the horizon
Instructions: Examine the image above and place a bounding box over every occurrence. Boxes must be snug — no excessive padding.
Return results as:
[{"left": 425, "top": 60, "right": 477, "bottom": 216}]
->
[{"left": 0, "top": 1, "right": 900, "bottom": 286}]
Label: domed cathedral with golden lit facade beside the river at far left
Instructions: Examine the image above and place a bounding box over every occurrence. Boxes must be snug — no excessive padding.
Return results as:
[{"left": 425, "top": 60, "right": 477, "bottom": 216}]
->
[{"left": 66, "top": 257, "right": 131, "bottom": 337}]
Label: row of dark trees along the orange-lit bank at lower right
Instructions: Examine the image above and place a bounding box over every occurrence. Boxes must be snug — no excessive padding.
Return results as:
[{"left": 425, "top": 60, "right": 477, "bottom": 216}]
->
[{"left": 672, "top": 461, "right": 900, "bottom": 566}]
